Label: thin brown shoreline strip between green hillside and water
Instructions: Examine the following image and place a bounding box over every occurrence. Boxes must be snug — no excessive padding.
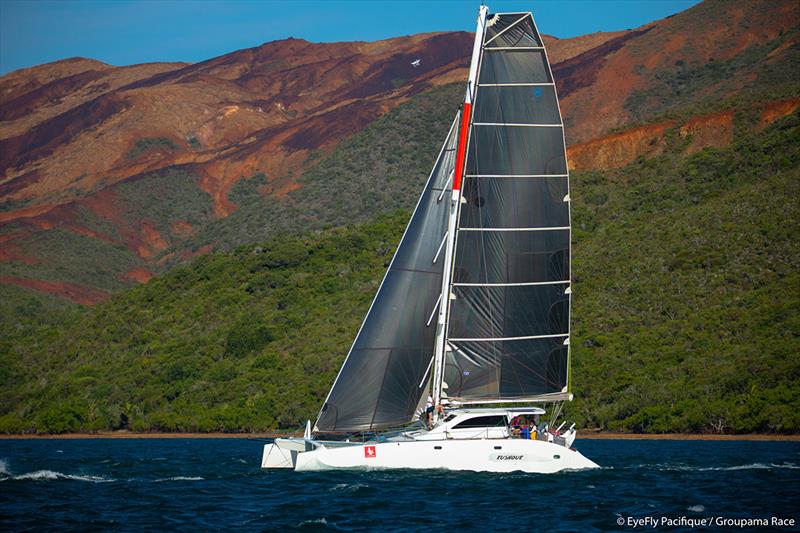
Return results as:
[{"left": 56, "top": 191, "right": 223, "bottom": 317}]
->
[{"left": 0, "top": 431, "right": 800, "bottom": 442}]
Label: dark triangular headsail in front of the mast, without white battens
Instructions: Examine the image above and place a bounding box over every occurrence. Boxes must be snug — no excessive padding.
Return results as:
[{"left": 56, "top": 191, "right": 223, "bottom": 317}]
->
[{"left": 314, "top": 117, "right": 458, "bottom": 433}]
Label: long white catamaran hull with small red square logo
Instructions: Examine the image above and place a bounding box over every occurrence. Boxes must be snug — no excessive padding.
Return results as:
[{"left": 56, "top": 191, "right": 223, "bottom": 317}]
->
[{"left": 262, "top": 439, "right": 599, "bottom": 474}]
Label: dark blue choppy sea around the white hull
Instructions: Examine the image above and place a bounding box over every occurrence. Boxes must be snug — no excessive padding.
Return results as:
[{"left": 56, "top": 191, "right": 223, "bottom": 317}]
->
[{"left": 0, "top": 438, "right": 800, "bottom": 531}]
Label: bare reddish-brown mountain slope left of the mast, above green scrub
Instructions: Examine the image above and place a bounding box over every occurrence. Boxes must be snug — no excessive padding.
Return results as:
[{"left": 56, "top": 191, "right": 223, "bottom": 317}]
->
[{"left": 0, "top": 33, "right": 471, "bottom": 303}]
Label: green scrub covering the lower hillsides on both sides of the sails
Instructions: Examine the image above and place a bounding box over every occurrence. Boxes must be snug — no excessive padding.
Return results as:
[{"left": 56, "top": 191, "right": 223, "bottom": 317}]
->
[{"left": 0, "top": 114, "right": 800, "bottom": 433}]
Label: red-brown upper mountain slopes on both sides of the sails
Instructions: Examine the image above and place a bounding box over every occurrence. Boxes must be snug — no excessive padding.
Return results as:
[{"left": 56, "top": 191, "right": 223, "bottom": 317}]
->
[{"left": 0, "top": 0, "right": 800, "bottom": 304}]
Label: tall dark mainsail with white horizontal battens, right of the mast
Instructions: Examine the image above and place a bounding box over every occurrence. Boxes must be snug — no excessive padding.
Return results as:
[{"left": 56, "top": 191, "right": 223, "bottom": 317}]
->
[{"left": 444, "top": 13, "right": 570, "bottom": 403}]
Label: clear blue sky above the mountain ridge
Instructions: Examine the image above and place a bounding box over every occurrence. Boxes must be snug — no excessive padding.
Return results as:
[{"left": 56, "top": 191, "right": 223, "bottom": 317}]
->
[{"left": 0, "top": 0, "right": 698, "bottom": 74}]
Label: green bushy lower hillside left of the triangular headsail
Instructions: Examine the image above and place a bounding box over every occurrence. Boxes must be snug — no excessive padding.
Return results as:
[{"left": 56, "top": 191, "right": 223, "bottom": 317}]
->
[{"left": 0, "top": 212, "right": 407, "bottom": 432}]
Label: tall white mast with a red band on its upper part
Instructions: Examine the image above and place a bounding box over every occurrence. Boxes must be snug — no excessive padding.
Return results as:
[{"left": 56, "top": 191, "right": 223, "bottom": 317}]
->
[{"left": 433, "top": 5, "right": 489, "bottom": 405}]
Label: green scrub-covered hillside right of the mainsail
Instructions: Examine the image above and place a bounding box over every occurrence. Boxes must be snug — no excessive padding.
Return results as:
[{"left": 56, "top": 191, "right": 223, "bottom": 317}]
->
[{"left": 569, "top": 111, "right": 800, "bottom": 433}]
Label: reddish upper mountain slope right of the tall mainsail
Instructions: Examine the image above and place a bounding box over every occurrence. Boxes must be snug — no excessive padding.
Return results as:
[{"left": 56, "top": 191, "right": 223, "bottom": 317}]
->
[{"left": 553, "top": 0, "right": 800, "bottom": 144}]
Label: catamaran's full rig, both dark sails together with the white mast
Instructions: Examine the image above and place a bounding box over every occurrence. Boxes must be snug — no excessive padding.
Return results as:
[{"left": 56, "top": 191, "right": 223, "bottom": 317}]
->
[{"left": 314, "top": 7, "right": 570, "bottom": 433}]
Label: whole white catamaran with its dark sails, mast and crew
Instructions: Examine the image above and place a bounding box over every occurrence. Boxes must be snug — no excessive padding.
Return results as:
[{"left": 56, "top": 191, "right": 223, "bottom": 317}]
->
[{"left": 262, "top": 6, "right": 597, "bottom": 473}]
